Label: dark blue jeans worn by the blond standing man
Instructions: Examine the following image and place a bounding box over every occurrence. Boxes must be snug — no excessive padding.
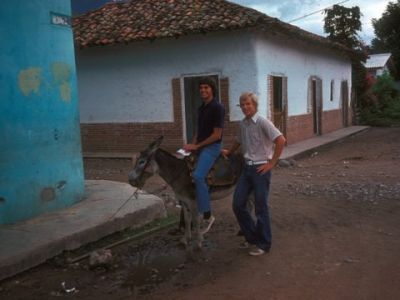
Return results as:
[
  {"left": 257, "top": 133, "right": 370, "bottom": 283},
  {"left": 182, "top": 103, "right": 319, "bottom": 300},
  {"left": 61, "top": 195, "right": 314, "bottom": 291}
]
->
[{"left": 232, "top": 165, "right": 271, "bottom": 251}]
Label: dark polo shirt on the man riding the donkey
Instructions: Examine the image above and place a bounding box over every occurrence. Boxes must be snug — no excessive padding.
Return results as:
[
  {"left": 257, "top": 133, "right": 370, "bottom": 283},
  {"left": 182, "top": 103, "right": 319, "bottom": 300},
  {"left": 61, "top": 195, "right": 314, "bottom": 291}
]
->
[{"left": 197, "top": 98, "right": 225, "bottom": 143}]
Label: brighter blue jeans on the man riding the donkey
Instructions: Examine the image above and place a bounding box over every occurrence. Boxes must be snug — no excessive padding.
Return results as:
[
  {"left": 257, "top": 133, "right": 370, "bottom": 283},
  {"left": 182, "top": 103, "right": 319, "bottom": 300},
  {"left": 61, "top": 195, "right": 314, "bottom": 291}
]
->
[{"left": 192, "top": 143, "right": 221, "bottom": 213}]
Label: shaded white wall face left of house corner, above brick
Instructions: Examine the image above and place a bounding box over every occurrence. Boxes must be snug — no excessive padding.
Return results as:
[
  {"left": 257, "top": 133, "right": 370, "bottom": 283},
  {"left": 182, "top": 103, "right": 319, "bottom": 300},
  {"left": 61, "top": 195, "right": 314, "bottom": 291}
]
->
[{"left": 76, "top": 32, "right": 257, "bottom": 123}]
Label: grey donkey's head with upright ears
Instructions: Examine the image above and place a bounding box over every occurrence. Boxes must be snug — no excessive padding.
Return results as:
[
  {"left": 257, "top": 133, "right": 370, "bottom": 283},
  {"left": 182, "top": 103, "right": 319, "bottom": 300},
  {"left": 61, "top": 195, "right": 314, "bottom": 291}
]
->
[{"left": 128, "top": 136, "right": 163, "bottom": 188}]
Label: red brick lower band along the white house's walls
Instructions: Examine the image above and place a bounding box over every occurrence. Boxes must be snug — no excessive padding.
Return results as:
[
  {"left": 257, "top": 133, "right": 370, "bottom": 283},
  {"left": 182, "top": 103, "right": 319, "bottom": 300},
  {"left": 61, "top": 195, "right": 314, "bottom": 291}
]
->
[{"left": 81, "top": 109, "right": 343, "bottom": 153}]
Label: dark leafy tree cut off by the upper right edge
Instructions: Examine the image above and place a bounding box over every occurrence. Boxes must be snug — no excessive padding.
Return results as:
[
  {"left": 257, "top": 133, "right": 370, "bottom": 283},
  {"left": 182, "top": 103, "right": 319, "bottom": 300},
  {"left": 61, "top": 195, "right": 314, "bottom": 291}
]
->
[{"left": 372, "top": 0, "right": 400, "bottom": 80}]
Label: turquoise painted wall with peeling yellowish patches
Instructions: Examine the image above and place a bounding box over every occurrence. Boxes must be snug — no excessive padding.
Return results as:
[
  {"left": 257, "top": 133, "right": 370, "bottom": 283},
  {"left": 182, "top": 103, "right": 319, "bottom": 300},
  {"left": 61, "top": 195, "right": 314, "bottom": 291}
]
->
[{"left": 0, "top": 0, "right": 84, "bottom": 224}]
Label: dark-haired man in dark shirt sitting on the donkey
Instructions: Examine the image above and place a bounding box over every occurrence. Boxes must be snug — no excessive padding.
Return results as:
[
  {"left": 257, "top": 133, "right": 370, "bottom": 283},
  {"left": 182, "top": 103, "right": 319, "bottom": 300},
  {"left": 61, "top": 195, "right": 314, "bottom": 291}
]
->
[{"left": 183, "top": 77, "right": 225, "bottom": 234}]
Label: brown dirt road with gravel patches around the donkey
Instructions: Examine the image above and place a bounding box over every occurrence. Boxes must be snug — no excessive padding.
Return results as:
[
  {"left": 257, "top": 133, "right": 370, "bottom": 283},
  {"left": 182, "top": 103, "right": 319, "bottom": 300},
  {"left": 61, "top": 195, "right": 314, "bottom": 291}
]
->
[{"left": 0, "top": 128, "right": 400, "bottom": 300}]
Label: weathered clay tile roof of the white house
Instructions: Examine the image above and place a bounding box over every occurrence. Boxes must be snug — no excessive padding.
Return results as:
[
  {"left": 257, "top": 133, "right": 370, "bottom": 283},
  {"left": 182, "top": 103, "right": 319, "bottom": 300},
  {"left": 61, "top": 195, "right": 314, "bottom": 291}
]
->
[{"left": 73, "top": 0, "right": 348, "bottom": 55}]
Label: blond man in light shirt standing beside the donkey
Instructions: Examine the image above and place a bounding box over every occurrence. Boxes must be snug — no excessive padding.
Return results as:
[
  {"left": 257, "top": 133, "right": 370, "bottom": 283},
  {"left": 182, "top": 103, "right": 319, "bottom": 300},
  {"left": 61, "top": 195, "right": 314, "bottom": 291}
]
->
[{"left": 222, "top": 93, "right": 286, "bottom": 256}]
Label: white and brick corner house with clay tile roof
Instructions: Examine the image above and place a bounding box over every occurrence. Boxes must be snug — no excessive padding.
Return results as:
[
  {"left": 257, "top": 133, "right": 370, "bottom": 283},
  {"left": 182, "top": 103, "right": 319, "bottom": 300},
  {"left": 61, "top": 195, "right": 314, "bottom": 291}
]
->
[{"left": 73, "top": 0, "right": 353, "bottom": 153}]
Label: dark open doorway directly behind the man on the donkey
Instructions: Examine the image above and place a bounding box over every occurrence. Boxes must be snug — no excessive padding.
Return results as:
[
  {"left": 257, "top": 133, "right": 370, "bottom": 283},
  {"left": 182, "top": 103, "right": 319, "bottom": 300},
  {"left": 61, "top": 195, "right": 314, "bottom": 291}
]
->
[{"left": 183, "top": 75, "right": 219, "bottom": 143}]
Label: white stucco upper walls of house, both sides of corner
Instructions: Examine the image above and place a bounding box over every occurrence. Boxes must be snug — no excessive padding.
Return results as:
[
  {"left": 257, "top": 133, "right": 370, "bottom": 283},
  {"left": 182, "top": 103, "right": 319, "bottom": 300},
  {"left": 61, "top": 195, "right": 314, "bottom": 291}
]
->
[{"left": 76, "top": 31, "right": 351, "bottom": 123}]
